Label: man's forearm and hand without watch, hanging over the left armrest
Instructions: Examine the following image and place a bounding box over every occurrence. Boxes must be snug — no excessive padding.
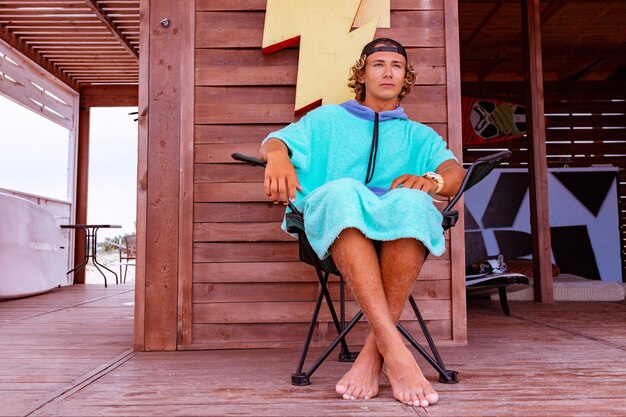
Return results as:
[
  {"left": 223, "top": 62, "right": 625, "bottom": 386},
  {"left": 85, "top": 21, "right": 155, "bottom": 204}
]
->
[{"left": 259, "top": 138, "right": 302, "bottom": 205}]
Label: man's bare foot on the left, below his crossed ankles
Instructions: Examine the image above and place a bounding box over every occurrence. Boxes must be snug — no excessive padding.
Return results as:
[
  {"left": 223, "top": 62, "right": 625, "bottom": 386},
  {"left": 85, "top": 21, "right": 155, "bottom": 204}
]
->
[{"left": 335, "top": 352, "right": 383, "bottom": 400}]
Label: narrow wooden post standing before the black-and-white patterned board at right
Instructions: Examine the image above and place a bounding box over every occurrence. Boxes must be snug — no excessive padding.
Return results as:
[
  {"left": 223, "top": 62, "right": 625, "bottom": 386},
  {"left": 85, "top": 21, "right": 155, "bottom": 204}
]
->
[{"left": 522, "top": 0, "right": 554, "bottom": 303}]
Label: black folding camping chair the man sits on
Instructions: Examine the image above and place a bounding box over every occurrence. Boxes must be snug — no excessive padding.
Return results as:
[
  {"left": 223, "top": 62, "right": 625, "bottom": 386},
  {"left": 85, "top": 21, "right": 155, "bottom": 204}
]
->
[{"left": 231, "top": 151, "right": 511, "bottom": 386}]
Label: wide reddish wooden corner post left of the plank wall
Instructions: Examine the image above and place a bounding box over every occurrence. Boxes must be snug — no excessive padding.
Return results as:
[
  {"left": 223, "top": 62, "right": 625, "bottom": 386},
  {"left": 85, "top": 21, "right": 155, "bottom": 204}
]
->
[{"left": 135, "top": 0, "right": 184, "bottom": 350}]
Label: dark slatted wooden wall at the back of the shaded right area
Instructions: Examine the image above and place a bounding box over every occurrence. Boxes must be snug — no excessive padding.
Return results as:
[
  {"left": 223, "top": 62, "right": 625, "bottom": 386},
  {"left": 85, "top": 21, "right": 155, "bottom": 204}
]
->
[{"left": 462, "top": 81, "right": 626, "bottom": 279}]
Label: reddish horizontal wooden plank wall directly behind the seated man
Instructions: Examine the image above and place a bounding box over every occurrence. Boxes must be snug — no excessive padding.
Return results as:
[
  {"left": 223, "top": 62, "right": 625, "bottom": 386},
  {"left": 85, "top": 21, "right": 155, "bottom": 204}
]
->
[{"left": 189, "top": 0, "right": 464, "bottom": 349}]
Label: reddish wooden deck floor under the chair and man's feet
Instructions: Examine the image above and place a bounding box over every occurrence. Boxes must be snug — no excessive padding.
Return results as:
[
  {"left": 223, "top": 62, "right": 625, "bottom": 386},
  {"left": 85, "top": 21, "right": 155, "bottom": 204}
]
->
[{"left": 0, "top": 286, "right": 626, "bottom": 417}]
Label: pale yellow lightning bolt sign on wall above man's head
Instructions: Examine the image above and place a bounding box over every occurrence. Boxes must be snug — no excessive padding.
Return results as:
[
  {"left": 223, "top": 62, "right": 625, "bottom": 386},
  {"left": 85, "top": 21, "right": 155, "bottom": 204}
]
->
[{"left": 263, "top": 0, "right": 389, "bottom": 114}]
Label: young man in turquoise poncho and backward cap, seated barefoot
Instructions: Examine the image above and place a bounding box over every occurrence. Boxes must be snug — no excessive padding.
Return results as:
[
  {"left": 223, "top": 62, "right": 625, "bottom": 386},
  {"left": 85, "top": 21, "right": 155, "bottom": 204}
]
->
[{"left": 260, "top": 38, "right": 465, "bottom": 407}]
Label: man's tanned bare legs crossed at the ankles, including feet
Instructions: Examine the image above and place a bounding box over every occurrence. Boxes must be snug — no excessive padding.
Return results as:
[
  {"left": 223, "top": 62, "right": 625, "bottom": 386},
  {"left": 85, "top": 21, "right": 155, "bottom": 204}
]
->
[{"left": 331, "top": 229, "right": 437, "bottom": 407}]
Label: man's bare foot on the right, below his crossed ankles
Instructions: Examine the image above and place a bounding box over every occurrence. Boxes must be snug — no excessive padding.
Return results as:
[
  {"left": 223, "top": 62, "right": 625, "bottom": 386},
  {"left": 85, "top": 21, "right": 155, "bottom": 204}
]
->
[{"left": 385, "top": 345, "right": 439, "bottom": 407}]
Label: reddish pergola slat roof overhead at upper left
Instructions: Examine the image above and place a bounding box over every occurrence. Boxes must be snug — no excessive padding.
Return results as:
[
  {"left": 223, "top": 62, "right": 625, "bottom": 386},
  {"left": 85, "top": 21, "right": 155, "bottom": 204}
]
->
[{"left": 0, "top": 0, "right": 140, "bottom": 86}]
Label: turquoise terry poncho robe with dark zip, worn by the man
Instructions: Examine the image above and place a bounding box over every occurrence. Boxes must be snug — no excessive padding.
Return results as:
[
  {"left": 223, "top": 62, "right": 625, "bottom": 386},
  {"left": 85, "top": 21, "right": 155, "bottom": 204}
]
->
[{"left": 263, "top": 100, "right": 456, "bottom": 258}]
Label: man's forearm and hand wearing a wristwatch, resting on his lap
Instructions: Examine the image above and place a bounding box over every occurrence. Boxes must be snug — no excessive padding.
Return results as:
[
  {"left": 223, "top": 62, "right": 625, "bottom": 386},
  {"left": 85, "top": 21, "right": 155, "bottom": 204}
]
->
[{"left": 389, "top": 159, "right": 465, "bottom": 197}]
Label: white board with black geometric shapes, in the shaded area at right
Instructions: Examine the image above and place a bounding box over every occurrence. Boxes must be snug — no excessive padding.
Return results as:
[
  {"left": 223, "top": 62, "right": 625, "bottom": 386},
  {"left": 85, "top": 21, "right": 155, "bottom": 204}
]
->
[{"left": 465, "top": 167, "right": 622, "bottom": 282}]
